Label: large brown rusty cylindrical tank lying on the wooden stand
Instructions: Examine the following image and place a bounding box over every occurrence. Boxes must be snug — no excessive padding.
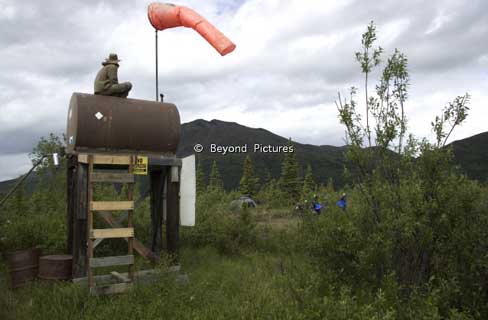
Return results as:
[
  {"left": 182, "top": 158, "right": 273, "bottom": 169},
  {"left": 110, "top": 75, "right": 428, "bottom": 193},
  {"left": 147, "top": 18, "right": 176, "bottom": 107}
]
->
[{"left": 66, "top": 93, "right": 181, "bottom": 155}]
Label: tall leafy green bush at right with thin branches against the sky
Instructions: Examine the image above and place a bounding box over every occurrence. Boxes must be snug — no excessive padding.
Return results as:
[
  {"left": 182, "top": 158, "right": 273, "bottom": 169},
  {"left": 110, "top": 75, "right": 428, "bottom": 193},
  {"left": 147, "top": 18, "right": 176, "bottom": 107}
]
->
[{"left": 304, "top": 24, "right": 488, "bottom": 318}]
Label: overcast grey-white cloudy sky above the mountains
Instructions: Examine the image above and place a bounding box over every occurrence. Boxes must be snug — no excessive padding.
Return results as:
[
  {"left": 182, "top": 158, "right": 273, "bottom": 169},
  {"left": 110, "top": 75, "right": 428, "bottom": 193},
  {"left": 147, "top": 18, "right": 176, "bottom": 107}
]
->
[{"left": 0, "top": 0, "right": 488, "bottom": 181}]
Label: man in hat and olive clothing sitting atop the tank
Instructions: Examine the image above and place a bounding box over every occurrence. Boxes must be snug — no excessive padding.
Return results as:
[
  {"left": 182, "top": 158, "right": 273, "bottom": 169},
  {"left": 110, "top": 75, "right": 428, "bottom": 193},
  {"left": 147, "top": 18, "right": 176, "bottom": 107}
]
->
[{"left": 94, "top": 53, "right": 132, "bottom": 98}]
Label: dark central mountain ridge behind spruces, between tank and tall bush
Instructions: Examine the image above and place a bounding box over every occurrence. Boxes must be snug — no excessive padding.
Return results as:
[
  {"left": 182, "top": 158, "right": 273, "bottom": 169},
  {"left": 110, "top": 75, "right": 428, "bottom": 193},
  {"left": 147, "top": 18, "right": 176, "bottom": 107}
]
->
[{"left": 178, "top": 120, "right": 345, "bottom": 189}]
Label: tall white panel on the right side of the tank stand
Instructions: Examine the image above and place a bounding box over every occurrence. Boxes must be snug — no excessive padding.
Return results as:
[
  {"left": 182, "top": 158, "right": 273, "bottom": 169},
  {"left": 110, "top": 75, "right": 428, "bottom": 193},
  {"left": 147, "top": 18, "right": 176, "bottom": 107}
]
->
[{"left": 180, "top": 155, "right": 196, "bottom": 227}]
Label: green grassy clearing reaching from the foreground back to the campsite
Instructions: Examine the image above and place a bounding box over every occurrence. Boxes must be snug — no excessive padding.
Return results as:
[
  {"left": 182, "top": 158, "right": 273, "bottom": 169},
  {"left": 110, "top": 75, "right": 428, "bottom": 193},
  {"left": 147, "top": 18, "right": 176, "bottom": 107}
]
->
[{"left": 0, "top": 195, "right": 483, "bottom": 320}]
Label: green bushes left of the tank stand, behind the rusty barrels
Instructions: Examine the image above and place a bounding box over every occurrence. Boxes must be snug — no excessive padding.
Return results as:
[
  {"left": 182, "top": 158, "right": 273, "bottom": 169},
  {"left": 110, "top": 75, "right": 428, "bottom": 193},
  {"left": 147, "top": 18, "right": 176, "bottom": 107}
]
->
[{"left": 0, "top": 133, "right": 67, "bottom": 253}]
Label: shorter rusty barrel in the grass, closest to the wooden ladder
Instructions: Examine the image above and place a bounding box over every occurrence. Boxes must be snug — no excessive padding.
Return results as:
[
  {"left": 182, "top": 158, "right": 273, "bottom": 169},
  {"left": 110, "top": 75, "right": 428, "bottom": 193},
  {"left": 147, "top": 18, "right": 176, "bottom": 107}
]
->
[{"left": 38, "top": 254, "right": 73, "bottom": 280}]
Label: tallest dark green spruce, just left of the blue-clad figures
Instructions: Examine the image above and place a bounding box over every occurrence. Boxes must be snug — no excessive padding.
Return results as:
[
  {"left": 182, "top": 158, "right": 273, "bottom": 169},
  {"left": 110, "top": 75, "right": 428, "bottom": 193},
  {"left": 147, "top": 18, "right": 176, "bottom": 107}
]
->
[{"left": 279, "top": 139, "right": 302, "bottom": 202}]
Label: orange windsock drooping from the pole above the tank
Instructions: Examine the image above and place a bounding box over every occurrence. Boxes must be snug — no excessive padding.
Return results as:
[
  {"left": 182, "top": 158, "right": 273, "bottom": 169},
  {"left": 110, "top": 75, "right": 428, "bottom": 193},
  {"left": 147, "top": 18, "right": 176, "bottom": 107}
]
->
[{"left": 147, "top": 2, "right": 236, "bottom": 56}]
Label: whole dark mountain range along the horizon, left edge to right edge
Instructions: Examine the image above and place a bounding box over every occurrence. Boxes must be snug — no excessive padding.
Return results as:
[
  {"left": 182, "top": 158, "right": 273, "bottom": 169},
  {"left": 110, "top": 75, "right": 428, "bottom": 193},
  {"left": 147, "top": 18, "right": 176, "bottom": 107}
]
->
[{"left": 0, "top": 120, "right": 488, "bottom": 194}]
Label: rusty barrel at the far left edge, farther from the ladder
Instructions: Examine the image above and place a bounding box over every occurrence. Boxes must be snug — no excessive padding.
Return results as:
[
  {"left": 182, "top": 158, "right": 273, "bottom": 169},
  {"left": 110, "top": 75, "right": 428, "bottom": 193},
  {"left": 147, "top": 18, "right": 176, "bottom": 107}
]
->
[{"left": 5, "top": 248, "right": 42, "bottom": 289}]
